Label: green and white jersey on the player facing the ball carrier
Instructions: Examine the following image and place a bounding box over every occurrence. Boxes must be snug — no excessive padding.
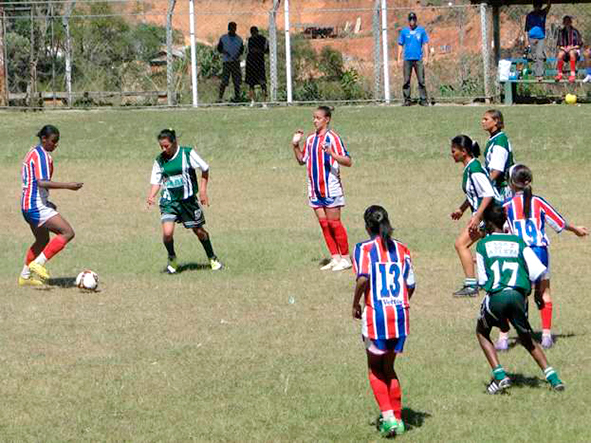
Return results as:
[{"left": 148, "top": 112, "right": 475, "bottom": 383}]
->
[{"left": 150, "top": 146, "right": 209, "bottom": 203}]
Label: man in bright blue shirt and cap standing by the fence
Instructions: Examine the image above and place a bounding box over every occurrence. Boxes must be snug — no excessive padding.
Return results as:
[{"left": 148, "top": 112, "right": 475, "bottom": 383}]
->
[{"left": 398, "top": 12, "right": 429, "bottom": 106}]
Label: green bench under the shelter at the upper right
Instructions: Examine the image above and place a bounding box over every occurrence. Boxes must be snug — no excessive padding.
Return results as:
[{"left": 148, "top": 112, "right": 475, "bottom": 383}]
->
[{"left": 500, "top": 57, "right": 587, "bottom": 105}]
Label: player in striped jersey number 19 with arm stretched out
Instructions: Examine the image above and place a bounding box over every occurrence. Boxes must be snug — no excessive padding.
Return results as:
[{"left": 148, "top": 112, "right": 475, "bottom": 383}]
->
[{"left": 495, "top": 165, "right": 589, "bottom": 351}]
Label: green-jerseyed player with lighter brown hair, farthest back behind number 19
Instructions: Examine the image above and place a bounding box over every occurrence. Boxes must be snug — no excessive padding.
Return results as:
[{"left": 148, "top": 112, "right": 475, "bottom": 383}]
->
[{"left": 482, "top": 109, "right": 514, "bottom": 201}]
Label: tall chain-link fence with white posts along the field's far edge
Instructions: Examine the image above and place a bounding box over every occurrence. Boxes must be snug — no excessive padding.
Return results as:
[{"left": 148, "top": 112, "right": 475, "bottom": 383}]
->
[{"left": 0, "top": 0, "right": 591, "bottom": 107}]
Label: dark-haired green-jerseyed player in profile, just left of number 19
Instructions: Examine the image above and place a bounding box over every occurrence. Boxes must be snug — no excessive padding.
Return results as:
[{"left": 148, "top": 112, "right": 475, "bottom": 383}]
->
[{"left": 451, "top": 135, "right": 498, "bottom": 297}]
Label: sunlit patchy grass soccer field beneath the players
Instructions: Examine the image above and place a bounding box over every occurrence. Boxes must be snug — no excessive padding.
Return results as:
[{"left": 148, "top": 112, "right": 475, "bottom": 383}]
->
[{"left": 0, "top": 106, "right": 591, "bottom": 442}]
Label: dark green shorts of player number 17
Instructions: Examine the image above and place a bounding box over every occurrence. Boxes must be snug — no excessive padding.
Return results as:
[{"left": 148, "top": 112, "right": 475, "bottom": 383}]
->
[{"left": 478, "top": 289, "right": 532, "bottom": 334}]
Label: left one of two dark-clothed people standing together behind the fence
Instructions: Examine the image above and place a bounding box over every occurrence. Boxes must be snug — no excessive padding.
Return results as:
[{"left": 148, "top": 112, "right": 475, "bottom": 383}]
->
[{"left": 217, "top": 22, "right": 244, "bottom": 102}]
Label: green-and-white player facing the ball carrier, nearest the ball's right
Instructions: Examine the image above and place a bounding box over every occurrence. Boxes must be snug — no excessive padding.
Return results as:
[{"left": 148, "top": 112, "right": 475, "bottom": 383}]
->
[{"left": 147, "top": 129, "right": 222, "bottom": 274}]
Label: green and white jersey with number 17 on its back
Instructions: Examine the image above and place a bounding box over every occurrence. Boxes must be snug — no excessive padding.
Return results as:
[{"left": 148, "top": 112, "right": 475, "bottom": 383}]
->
[{"left": 476, "top": 233, "right": 546, "bottom": 295}]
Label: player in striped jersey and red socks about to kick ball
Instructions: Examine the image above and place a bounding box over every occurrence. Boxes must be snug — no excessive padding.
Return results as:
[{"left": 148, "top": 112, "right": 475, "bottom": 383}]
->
[{"left": 18, "top": 125, "right": 83, "bottom": 286}]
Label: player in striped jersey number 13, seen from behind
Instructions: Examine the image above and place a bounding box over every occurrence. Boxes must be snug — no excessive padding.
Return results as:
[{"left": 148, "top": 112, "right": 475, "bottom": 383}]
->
[{"left": 353, "top": 206, "right": 415, "bottom": 437}]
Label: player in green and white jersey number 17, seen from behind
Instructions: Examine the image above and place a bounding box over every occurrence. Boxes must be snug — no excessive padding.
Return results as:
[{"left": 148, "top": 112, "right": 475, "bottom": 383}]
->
[{"left": 476, "top": 205, "right": 564, "bottom": 394}]
